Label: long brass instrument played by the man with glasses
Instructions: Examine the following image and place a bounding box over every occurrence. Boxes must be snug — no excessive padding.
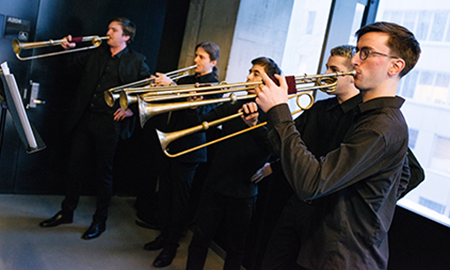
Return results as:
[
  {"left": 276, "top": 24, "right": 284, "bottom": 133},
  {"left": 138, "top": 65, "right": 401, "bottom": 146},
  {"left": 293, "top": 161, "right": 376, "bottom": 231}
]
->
[{"left": 138, "top": 71, "right": 355, "bottom": 127}]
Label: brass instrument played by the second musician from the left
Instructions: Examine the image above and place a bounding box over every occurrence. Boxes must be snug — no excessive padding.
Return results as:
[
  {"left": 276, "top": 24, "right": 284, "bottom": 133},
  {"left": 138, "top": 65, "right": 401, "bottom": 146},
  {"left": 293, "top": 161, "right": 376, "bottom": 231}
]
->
[{"left": 104, "top": 65, "right": 197, "bottom": 107}]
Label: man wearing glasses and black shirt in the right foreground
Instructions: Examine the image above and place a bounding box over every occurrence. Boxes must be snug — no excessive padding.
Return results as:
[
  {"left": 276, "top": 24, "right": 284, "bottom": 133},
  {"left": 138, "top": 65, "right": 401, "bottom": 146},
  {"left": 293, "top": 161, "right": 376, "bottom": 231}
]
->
[{"left": 256, "top": 22, "right": 420, "bottom": 269}]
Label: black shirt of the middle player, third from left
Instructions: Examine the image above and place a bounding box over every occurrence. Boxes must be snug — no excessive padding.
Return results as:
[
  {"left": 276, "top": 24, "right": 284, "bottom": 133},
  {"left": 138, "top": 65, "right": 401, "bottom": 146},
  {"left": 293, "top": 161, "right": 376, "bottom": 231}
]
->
[{"left": 204, "top": 101, "right": 271, "bottom": 198}]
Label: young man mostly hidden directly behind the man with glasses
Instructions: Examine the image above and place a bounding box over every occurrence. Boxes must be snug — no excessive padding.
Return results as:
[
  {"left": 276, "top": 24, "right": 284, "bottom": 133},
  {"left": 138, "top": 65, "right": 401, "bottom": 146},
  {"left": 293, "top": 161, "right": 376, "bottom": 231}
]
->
[{"left": 252, "top": 45, "right": 362, "bottom": 269}]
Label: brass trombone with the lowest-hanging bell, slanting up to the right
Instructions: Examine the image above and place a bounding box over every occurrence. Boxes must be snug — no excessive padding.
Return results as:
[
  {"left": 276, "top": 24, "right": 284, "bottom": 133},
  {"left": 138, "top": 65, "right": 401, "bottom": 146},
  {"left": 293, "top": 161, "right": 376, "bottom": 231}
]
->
[{"left": 151, "top": 71, "right": 356, "bottom": 158}]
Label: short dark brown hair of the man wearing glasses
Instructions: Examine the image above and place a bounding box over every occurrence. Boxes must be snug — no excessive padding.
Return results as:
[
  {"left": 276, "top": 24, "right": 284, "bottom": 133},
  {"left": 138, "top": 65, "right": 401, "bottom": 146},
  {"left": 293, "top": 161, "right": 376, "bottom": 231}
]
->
[{"left": 355, "top": 22, "right": 421, "bottom": 77}]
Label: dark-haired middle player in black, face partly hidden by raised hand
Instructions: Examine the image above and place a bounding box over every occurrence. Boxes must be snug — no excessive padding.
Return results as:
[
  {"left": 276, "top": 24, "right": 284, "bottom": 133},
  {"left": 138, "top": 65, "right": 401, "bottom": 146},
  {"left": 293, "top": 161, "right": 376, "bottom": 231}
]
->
[{"left": 186, "top": 57, "right": 281, "bottom": 270}]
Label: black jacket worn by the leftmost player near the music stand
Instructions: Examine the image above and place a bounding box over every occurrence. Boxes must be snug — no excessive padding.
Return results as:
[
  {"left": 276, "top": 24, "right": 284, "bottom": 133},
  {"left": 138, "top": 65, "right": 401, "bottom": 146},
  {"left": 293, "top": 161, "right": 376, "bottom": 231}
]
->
[{"left": 65, "top": 45, "right": 150, "bottom": 139}]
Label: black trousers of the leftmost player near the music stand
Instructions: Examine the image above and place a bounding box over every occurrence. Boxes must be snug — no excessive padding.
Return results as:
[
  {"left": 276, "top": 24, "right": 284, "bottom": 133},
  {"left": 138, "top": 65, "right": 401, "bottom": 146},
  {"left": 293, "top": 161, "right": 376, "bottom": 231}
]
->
[{"left": 61, "top": 113, "right": 120, "bottom": 221}]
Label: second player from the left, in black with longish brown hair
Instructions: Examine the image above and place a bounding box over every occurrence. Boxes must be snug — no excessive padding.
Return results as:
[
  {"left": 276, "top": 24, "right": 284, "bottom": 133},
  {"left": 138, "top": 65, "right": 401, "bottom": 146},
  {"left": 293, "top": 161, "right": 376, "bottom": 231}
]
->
[{"left": 144, "top": 42, "right": 222, "bottom": 267}]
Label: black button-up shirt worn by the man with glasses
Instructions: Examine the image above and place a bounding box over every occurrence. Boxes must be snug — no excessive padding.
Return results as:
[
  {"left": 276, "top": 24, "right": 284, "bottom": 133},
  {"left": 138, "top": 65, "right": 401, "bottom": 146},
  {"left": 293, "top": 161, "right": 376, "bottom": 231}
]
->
[{"left": 267, "top": 97, "right": 408, "bottom": 269}]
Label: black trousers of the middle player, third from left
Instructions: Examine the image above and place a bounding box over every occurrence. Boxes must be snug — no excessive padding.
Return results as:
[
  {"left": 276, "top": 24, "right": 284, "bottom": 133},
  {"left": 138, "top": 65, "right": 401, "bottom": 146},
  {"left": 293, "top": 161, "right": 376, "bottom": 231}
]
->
[{"left": 186, "top": 187, "right": 256, "bottom": 270}]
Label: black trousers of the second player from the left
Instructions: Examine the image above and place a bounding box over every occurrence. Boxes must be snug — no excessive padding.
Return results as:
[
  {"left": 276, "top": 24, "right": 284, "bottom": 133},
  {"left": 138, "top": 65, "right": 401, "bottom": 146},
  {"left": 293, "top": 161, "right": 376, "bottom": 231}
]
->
[{"left": 158, "top": 159, "right": 198, "bottom": 247}]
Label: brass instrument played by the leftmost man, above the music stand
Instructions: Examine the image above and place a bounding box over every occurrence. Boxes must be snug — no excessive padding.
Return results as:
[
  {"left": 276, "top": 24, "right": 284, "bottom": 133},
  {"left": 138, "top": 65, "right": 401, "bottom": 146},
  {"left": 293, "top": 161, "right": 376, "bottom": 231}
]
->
[{"left": 12, "top": 36, "right": 110, "bottom": 61}]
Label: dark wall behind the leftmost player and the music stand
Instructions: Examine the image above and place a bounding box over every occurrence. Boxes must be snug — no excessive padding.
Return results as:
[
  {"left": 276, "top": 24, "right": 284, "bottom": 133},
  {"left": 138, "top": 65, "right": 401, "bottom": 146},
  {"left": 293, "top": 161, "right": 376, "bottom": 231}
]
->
[{"left": 0, "top": 0, "right": 189, "bottom": 194}]
